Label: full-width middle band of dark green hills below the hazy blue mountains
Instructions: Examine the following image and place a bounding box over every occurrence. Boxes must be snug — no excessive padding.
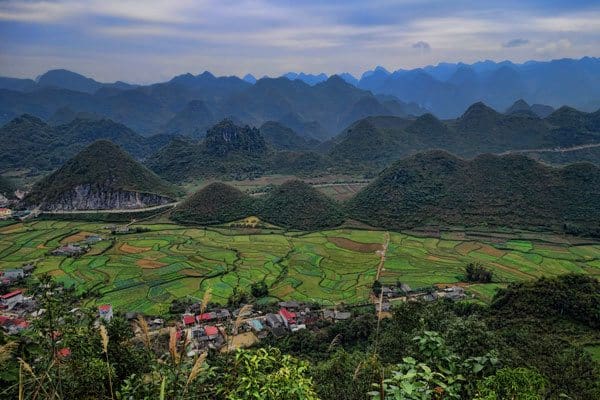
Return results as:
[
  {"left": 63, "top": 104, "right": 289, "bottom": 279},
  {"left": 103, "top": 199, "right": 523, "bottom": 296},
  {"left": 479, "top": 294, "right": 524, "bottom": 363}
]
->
[{"left": 0, "top": 100, "right": 600, "bottom": 182}]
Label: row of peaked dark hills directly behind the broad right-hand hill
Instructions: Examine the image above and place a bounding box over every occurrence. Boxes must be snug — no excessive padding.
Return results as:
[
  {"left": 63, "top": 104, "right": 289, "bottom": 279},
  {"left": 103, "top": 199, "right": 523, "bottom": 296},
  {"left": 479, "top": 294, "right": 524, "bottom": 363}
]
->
[{"left": 325, "top": 103, "right": 600, "bottom": 169}]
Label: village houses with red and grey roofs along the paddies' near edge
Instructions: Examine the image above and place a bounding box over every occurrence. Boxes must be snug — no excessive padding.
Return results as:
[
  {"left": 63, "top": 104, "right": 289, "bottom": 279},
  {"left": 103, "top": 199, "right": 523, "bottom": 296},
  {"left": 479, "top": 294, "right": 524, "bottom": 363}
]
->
[{"left": 0, "top": 253, "right": 466, "bottom": 354}]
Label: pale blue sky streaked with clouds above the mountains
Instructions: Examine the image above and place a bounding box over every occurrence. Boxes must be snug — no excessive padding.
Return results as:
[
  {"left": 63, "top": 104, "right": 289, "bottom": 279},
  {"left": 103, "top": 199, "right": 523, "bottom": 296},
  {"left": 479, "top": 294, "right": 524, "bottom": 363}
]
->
[{"left": 0, "top": 0, "right": 600, "bottom": 83}]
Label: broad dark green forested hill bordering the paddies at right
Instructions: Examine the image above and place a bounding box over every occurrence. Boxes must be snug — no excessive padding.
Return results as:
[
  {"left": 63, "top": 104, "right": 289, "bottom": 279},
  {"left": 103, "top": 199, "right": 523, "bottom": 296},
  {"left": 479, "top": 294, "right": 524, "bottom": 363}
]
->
[{"left": 348, "top": 151, "right": 600, "bottom": 235}]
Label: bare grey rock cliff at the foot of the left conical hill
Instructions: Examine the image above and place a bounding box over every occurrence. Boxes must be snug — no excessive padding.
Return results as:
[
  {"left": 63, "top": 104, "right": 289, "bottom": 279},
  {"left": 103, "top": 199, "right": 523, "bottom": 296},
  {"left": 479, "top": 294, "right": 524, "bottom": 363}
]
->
[{"left": 38, "top": 184, "right": 173, "bottom": 211}]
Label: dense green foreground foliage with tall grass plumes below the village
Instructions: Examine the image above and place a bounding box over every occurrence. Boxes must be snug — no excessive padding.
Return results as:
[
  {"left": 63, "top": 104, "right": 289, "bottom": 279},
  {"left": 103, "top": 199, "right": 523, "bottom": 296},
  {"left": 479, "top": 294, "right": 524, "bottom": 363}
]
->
[{"left": 0, "top": 275, "right": 600, "bottom": 400}]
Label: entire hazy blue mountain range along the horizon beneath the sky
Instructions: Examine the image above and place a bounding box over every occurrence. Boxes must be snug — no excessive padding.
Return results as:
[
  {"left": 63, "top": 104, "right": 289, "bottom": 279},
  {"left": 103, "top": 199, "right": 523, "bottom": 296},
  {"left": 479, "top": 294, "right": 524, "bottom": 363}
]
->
[{"left": 0, "top": 57, "right": 600, "bottom": 136}]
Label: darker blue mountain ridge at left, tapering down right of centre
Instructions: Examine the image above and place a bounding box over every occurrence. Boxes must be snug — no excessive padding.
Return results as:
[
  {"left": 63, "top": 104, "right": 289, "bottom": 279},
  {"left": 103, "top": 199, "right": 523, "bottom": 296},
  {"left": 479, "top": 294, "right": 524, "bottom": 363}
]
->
[{"left": 0, "top": 70, "right": 425, "bottom": 140}]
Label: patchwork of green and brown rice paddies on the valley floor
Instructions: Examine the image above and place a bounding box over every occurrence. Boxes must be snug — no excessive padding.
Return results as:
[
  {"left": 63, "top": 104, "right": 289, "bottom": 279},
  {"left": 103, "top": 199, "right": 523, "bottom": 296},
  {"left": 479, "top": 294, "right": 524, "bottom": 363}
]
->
[{"left": 0, "top": 220, "right": 600, "bottom": 314}]
